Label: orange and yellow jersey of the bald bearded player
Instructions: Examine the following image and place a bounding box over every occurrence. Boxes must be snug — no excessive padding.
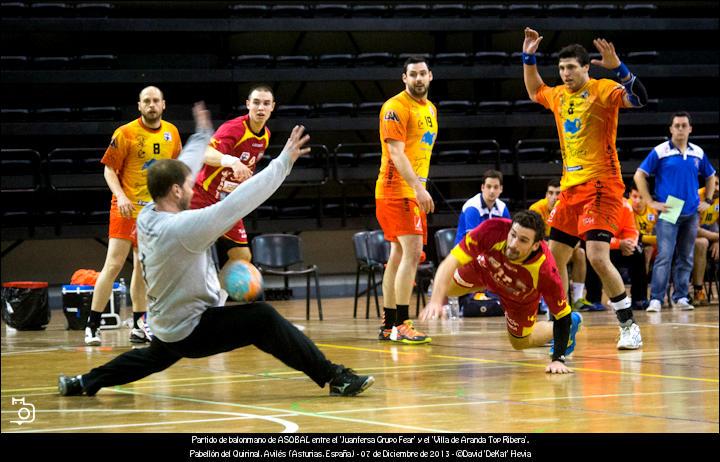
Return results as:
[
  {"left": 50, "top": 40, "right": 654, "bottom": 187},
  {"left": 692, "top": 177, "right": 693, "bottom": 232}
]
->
[{"left": 101, "top": 117, "right": 182, "bottom": 218}]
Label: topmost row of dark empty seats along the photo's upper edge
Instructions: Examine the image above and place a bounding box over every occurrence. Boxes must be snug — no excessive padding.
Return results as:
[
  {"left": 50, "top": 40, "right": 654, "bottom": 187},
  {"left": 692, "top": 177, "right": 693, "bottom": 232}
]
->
[{"left": 2, "top": 2, "right": 658, "bottom": 18}]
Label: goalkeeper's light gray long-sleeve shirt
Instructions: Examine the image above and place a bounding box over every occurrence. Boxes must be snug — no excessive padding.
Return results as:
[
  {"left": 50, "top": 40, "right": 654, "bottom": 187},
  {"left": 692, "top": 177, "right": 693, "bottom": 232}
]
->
[{"left": 137, "top": 130, "right": 292, "bottom": 342}]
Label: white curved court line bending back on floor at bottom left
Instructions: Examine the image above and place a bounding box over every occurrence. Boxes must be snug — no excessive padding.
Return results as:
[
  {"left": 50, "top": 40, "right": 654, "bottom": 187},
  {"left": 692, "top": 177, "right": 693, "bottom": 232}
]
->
[{"left": 2, "top": 409, "right": 300, "bottom": 433}]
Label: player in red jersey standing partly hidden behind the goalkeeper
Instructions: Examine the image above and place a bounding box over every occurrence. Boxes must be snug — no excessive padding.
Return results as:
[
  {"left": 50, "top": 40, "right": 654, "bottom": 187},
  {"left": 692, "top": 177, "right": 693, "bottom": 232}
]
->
[{"left": 191, "top": 84, "right": 275, "bottom": 267}]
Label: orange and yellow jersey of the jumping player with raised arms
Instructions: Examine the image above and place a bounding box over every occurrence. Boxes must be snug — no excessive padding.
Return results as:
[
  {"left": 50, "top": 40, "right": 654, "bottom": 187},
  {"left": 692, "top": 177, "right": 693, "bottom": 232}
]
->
[{"left": 535, "top": 79, "right": 625, "bottom": 190}]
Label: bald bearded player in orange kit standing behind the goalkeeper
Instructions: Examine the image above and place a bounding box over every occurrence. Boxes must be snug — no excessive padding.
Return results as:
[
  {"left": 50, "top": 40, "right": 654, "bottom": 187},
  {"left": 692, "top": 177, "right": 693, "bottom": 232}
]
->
[{"left": 85, "top": 86, "right": 181, "bottom": 346}]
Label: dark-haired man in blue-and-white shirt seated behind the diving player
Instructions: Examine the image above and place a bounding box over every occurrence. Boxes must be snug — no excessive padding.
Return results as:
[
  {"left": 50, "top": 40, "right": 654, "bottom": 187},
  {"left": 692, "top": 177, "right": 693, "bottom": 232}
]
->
[{"left": 455, "top": 170, "right": 510, "bottom": 245}]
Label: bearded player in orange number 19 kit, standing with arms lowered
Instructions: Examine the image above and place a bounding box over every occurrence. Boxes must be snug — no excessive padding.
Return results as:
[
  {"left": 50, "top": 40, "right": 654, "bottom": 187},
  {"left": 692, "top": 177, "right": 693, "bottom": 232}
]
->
[{"left": 375, "top": 57, "right": 438, "bottom": 344}]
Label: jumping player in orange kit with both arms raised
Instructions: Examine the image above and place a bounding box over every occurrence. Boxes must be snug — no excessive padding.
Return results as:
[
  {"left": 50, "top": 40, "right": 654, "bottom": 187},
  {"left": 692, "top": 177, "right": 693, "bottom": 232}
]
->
[{"left": 522, "top": 28, "right": 647, "bottom": 350}]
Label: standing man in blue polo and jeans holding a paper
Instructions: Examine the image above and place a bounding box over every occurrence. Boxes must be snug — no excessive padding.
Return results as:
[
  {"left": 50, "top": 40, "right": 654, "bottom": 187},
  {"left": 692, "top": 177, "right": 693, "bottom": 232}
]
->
[{"left": 634, "top": 112, "right": 715, "bottom": 312}]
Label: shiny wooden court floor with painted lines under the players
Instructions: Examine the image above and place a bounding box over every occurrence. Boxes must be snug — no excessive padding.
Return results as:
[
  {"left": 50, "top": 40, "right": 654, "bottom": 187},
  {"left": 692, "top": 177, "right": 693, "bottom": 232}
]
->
[{"left": 1, "top": 299, "right": 719, "bottom": 433}]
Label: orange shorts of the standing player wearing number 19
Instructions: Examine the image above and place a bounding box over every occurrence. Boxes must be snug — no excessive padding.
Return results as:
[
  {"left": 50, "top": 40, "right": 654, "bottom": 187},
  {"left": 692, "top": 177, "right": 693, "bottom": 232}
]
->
[{"left": 375, "top": 198, "right": 427, "bottom": 245}]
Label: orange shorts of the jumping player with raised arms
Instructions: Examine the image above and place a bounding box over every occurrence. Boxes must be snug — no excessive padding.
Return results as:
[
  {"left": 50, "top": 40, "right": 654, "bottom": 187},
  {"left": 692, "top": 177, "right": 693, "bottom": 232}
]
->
[{"left": 548, "top": 178, "right": 625, "bottom": 239}]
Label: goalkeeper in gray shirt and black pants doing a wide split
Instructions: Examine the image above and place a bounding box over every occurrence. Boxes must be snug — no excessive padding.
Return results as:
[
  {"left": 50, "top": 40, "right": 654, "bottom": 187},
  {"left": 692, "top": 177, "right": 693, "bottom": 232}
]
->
[{"left": 58, "top": 103, "right": 375, "bottom": 396}]
